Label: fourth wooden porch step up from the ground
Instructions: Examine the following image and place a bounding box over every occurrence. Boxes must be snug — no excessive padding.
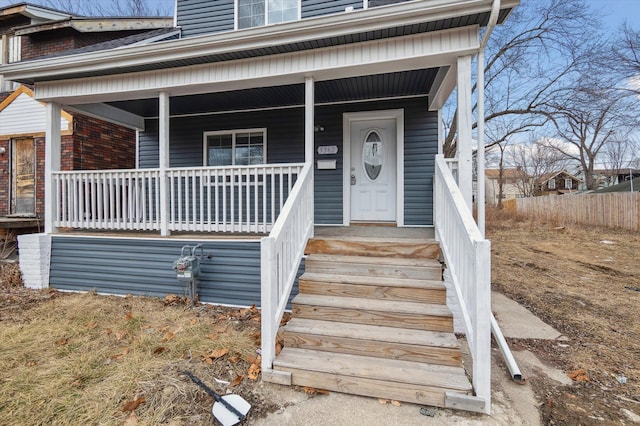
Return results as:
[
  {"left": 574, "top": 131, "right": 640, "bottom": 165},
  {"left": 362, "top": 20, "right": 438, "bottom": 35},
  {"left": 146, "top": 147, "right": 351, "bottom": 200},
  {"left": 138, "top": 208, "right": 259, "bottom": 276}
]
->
[{"left": 298, "top": 272, "right": 447, "bottom": 304}]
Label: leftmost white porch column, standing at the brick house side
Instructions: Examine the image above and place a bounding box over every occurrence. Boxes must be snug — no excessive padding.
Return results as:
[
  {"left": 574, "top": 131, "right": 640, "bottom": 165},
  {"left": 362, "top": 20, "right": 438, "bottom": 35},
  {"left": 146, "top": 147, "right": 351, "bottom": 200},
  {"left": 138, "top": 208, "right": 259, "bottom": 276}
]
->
[{"left": 44, "top": 102, "right": 62, "bottom": 234}]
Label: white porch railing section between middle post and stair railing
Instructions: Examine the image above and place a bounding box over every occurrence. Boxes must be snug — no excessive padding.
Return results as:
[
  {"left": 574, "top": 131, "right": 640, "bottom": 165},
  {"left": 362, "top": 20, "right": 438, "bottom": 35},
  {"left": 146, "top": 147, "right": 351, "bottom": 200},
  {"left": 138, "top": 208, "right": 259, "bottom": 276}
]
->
[{"left": 167, "top": 164, "right": 303, "bottom": 233}]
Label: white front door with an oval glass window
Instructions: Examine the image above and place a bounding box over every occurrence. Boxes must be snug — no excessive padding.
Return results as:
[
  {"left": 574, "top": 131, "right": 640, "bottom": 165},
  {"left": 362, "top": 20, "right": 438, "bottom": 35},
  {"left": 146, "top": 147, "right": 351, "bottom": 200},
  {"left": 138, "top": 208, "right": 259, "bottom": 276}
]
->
[{"left": 349, "top": 119, "right": 397, "bottom": 222}]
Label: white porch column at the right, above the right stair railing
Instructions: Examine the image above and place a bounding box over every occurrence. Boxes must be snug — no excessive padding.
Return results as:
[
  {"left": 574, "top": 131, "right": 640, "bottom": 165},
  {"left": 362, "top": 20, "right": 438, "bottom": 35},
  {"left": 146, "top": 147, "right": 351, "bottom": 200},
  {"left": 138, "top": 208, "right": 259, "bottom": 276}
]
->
[{"left": 456, "top": 55, "right": 473, "bottom": 210}]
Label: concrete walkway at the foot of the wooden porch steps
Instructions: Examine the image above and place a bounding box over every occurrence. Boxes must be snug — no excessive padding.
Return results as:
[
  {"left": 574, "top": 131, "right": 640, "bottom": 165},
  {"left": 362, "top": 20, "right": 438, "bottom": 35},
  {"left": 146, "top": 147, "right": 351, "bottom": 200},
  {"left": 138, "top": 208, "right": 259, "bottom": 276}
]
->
[{"left": 250, "top": 293, "right": 571, "bottom": 426}]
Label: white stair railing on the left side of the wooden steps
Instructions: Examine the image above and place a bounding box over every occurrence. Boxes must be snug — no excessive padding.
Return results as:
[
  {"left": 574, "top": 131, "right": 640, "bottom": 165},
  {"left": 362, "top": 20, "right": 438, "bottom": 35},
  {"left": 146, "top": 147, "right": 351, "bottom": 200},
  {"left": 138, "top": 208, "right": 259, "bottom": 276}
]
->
[{"left": 260, "top": 163, "right": 313, "bottom": 372}]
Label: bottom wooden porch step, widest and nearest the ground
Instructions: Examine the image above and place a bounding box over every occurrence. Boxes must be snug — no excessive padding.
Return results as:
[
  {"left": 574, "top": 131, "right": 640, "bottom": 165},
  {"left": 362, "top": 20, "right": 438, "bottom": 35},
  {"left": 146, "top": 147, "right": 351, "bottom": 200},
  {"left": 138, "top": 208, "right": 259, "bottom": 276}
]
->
[{"left": 274, "top": 347, "right": 472, "bottom": 407}]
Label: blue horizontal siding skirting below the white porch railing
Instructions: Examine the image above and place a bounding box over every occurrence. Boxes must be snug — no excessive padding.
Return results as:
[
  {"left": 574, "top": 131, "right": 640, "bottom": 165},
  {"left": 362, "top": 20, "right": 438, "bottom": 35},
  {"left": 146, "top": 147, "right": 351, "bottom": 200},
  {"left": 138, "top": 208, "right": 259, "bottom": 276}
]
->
[{"left": 50, "top": 236, "right": 304, "bottom": 306}]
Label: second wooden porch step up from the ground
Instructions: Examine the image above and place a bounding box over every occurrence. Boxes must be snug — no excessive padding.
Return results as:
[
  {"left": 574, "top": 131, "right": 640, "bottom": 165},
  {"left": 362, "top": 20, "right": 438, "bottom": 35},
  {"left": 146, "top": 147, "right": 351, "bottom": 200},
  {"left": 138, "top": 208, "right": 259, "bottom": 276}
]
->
[{"left": 284, "top": 318, "right": 462, "bottom": 367}]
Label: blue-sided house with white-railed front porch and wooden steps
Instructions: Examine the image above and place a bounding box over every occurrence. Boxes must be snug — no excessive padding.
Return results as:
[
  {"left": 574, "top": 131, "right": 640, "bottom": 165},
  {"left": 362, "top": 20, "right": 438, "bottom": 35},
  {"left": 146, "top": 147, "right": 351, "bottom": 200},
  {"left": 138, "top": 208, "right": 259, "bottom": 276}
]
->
[{"left": 2, "top": 0, "right": 518, "bottom": 413}]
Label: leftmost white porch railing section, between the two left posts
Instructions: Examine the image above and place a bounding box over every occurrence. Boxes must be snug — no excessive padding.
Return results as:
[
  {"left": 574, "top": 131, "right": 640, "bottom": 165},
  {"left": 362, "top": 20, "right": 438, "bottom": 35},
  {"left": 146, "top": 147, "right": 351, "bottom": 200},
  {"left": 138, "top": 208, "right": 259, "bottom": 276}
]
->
[{"left": 52, "top": 169, "right": 160, "bottom": 230}]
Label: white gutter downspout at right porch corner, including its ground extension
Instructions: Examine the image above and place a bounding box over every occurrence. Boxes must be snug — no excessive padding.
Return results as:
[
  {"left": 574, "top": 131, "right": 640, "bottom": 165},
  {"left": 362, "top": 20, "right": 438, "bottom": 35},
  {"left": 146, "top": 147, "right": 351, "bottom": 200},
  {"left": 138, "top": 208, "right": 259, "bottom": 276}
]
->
[{"left": 476, "top": 0, "right": 524, "bottom": 382}]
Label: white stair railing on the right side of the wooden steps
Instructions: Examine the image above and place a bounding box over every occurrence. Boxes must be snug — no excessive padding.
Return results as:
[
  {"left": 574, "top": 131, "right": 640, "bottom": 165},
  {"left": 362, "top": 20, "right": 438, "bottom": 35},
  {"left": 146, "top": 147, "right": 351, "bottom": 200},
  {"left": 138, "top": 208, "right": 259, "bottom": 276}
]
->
[{"left": 434, "top": 155, "right": 491, "bottom": 414}]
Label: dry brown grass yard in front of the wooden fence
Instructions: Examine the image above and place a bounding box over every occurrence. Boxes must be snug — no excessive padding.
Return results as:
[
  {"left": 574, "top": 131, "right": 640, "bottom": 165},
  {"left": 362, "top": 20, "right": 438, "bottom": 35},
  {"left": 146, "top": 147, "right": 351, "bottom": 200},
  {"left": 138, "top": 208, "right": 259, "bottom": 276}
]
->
[{"left": 487, "top": 206, "right": 640, "bottom": 424}]
